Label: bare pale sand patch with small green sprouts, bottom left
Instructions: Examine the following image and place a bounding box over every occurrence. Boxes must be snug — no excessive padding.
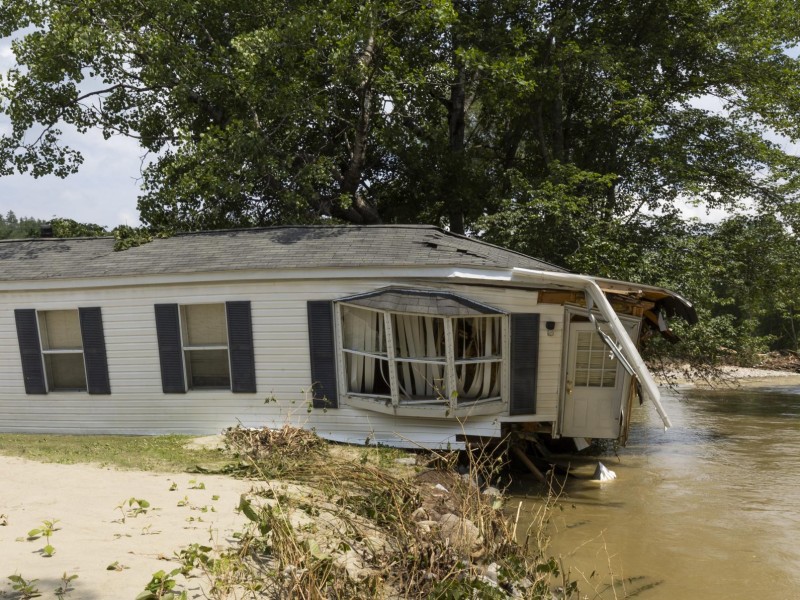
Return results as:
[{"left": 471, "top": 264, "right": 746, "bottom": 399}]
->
[{"left": 0, "top": 456, "right": 252, "bottom": 600}]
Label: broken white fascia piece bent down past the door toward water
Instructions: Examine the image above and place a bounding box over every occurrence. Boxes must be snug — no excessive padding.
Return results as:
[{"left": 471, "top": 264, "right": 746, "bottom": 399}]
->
[{"left": 513, "top": 268, "right": 672, "bottom": 428}]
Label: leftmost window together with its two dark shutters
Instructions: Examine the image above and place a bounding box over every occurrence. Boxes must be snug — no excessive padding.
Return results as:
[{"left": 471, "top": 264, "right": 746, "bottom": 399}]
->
[{"left": 14, "top": 307, "right": 111, "bottom": 394}]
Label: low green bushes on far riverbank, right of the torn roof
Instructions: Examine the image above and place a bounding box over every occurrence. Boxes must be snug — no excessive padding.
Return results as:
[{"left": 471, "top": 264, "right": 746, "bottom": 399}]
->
[{"left": 570, "top": 215, "right": 800, "bottom": 365}]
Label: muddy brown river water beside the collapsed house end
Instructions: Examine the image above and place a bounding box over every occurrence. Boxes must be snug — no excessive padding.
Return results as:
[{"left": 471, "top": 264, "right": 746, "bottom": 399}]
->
[{"left": 521, "top": 380, "right": 800, "bottom": 600}]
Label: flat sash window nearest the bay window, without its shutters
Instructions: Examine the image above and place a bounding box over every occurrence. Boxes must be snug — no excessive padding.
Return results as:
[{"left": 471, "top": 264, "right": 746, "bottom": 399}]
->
[{"left": 180, "top": 304, "right": 231, "bottom": 389}]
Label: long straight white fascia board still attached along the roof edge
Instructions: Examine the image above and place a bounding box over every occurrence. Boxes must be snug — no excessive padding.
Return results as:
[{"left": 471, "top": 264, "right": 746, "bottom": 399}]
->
[{"left": 0, "top": 266, "right": 511, "bottom": 293}]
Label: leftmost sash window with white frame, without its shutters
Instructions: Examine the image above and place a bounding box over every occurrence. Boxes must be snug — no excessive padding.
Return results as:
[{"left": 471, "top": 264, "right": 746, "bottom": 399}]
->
[{"left": 37, "top": 310, "right": 86, "bottom": 391}]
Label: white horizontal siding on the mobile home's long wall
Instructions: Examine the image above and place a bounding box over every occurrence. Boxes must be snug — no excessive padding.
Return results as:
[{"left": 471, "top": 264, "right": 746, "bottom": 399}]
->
[{"left": 0, "top": 279, "right": 563, "bottom": 446}]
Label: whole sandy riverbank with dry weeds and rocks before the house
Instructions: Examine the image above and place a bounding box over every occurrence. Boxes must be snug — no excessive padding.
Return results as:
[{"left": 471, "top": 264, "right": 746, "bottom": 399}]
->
[{"left": 0, "top": 427, "right": 571, "bottom": 600}]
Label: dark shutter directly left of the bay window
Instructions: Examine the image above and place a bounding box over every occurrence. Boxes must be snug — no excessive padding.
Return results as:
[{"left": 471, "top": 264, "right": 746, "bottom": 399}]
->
[{"left": 308, "top": 300, "right": 339, "bottom": 408}]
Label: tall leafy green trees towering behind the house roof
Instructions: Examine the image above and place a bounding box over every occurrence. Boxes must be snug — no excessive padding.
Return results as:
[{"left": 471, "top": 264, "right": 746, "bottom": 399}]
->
[{"left": 0, "top": 0, "right": 800, "bottom": 241}]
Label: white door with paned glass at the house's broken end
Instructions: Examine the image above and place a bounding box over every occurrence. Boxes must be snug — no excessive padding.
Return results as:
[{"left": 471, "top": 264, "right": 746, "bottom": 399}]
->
[{"left": 561, "top": 322, "right": 639, "bottom": 439}]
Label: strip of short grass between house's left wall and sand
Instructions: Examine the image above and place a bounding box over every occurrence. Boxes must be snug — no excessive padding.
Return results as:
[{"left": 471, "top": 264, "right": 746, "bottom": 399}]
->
[{"left": 0, "top": 433, "right": 230, "bottom": 473}]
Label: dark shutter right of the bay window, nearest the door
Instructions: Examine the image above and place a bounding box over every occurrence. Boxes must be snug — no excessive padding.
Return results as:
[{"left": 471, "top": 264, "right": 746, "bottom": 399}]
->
[{"left": 509, "top": 314, "right": 539, "bottom": 415}]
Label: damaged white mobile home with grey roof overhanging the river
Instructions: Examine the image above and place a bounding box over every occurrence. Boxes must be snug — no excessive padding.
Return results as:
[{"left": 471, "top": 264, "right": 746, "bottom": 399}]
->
[{"left": 0, "top": 226, "right": 696, "bottom": 447}]
